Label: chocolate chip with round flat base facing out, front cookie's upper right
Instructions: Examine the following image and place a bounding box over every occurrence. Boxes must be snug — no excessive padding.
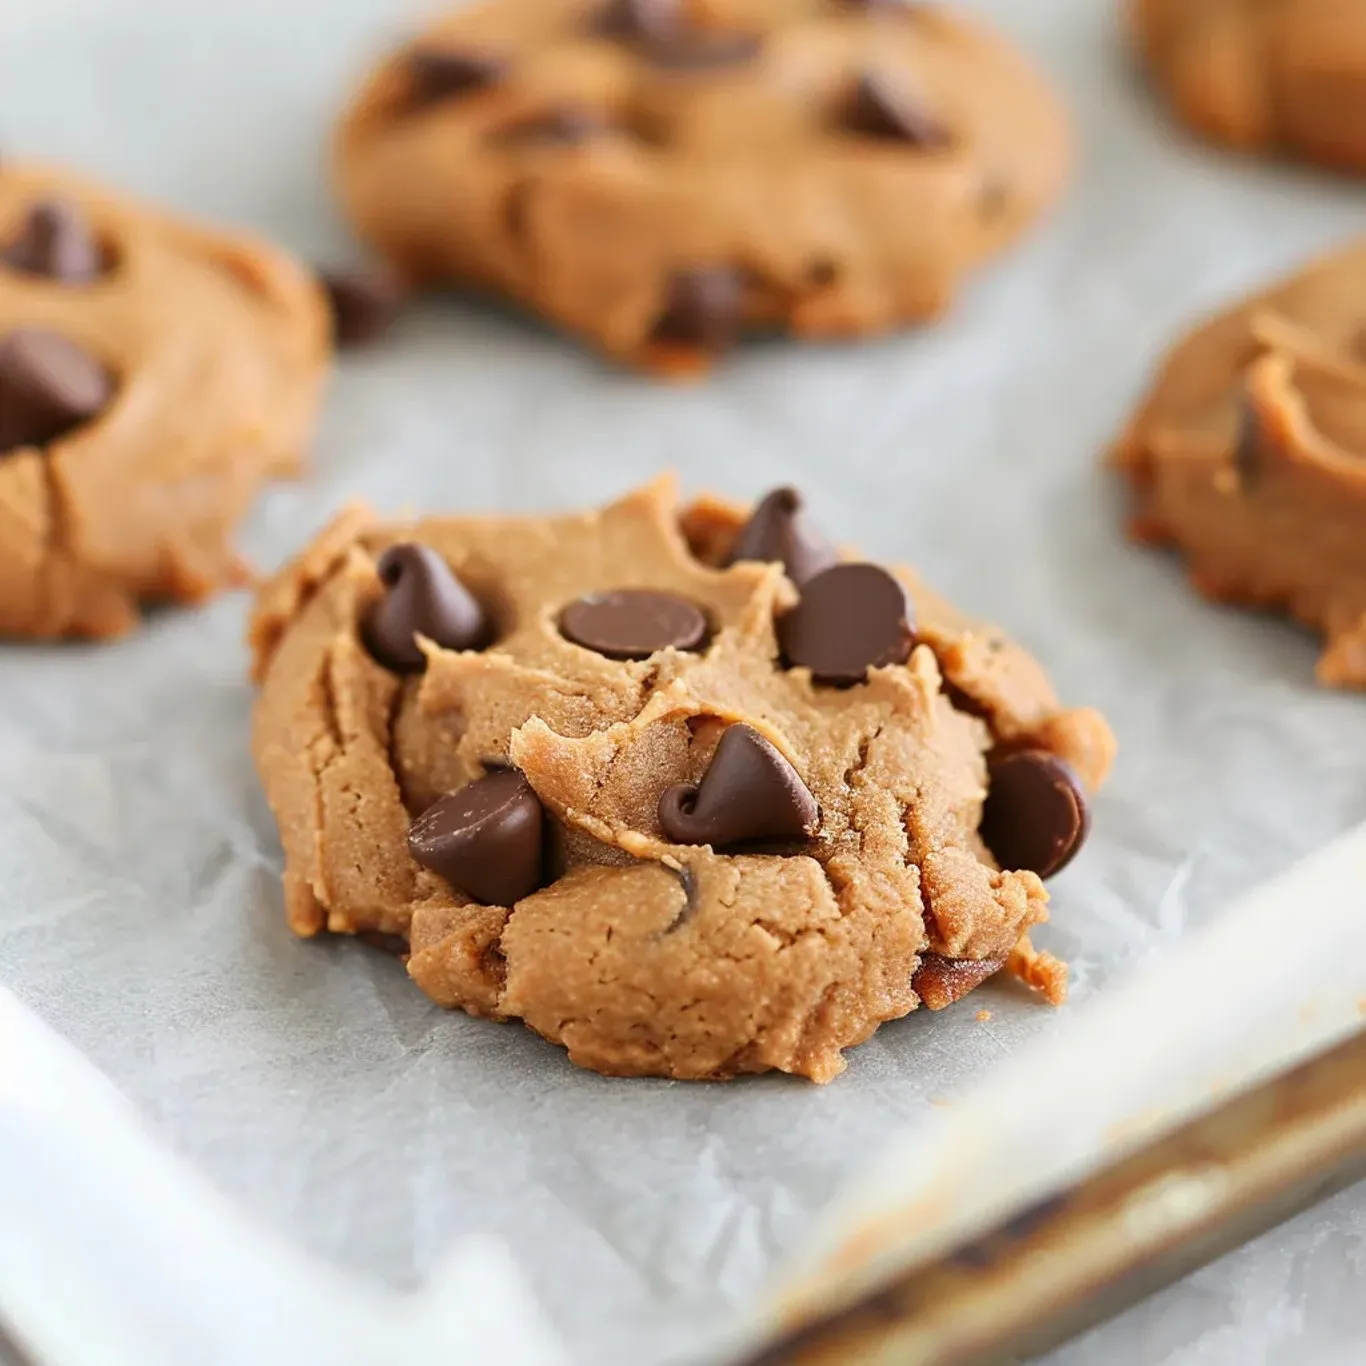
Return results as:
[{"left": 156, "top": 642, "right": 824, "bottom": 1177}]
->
[{"left": 777, "top": 564, "right": 915, "bottom": 687}]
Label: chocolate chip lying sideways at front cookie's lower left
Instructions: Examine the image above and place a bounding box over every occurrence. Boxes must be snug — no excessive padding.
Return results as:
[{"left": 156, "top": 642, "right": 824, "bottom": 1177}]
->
[{"left": 408, "top": 769, "right": 545, "bottom": 906}]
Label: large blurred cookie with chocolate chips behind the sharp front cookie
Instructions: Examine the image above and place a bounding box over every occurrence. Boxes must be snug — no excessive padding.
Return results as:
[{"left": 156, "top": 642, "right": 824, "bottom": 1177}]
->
[{"left": 336, "top": 0, "right": 1070, "bottom": 373}]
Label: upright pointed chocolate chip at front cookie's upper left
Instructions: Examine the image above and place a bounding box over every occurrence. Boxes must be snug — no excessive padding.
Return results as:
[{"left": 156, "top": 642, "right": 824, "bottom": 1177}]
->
[{"left": 362, "top": 542, "right": 489, "bottom": 673}]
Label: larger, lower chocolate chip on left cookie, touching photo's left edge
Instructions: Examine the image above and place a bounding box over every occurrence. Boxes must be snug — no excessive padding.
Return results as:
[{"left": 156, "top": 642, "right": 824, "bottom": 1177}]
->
[{"left": 0, "top": 328, "right": 113, "bottom": 454}]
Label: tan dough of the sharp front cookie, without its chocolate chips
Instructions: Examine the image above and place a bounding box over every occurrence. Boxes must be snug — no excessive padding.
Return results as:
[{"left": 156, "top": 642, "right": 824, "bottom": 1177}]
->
[{"left": 251, "top": 478, "right": 1113, "bottom": 1082}]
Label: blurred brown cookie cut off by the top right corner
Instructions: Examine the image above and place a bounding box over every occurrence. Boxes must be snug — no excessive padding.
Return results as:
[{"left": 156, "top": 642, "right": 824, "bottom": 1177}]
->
[{"left": 1131, "top": 0, "right": 1366, "bottom": 171}]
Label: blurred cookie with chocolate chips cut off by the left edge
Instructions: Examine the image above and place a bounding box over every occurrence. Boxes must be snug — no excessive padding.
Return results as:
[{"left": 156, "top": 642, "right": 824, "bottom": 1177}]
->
[{"left": 0, "top": 160, "right": 329, "bottom": 638}]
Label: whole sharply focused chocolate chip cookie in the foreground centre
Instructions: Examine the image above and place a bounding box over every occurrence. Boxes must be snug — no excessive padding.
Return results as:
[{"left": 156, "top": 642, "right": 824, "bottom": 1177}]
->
[{"left": 253, "top": 479, "right": 1112, "bottom": 1081}]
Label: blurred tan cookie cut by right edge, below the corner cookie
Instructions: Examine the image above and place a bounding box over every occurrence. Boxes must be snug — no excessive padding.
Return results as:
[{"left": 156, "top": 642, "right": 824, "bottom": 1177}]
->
[{"left": 1111, "top": 243, "right": 1366, "bottom": 687}]
